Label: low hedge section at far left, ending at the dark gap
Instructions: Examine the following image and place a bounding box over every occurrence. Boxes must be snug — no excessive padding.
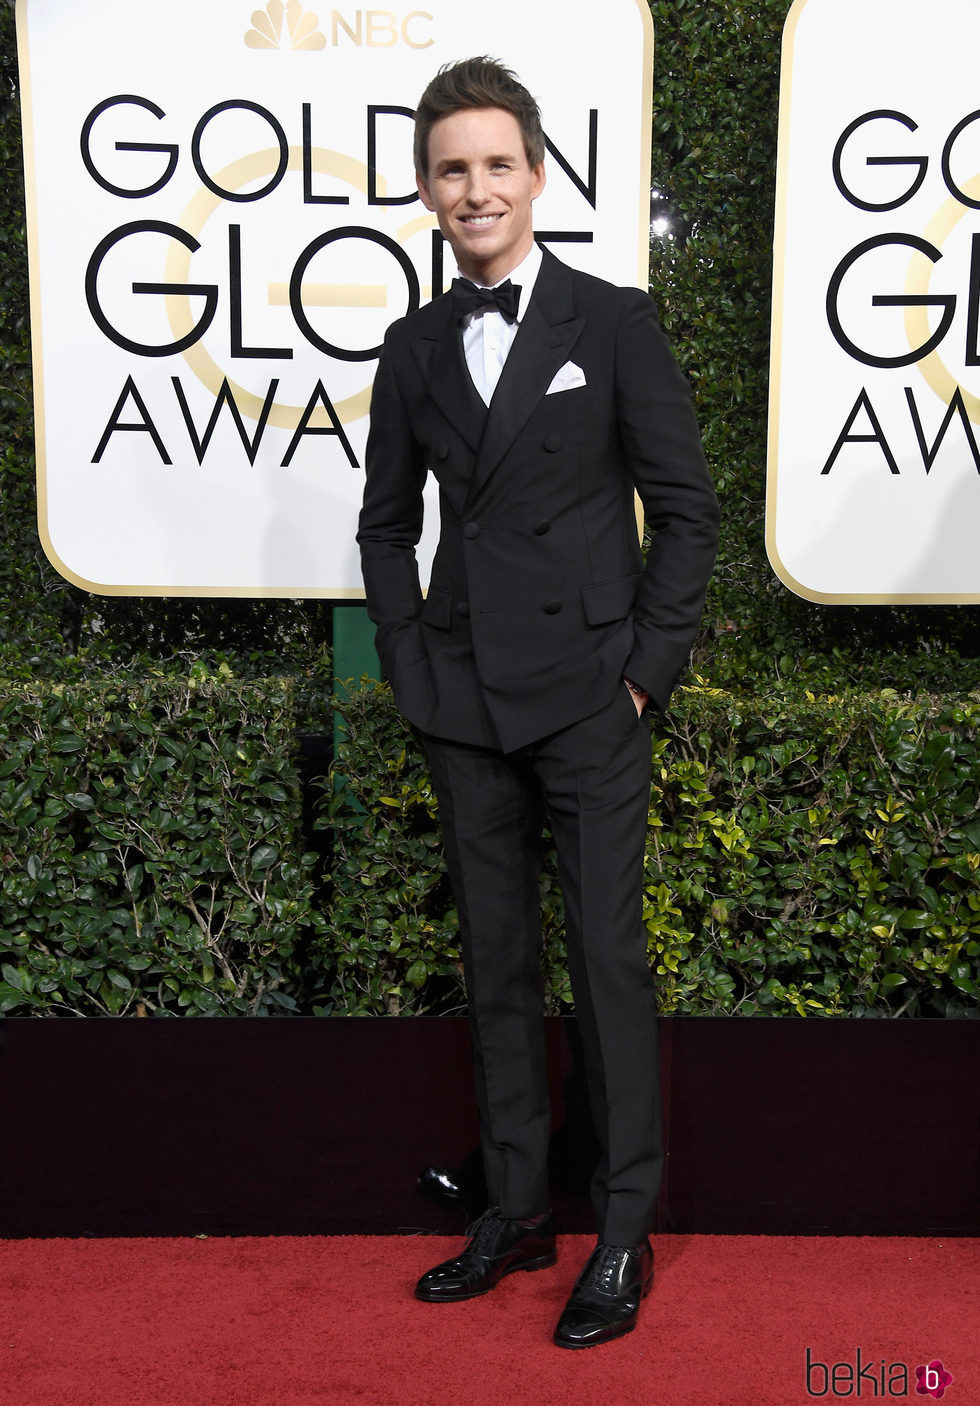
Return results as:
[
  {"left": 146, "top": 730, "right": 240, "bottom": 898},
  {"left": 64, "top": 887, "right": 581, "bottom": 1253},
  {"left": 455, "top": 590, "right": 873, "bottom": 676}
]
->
[{"left": 0, "top": 678, "right": 329, "bottom": 1015}]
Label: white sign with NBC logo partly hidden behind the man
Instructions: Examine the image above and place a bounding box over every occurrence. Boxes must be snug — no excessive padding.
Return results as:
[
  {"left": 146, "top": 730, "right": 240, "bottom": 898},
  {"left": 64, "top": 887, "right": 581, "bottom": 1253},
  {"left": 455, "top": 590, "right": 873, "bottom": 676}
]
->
[{"left": 17, "top": 0, "right": 652, "bottom": 596}]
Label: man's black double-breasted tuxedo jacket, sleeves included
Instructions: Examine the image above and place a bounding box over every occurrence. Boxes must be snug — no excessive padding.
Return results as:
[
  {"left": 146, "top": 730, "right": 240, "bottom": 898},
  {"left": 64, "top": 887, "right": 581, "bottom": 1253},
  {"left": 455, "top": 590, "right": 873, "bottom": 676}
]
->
[{"left": 359, "top": 250, "right": 717, "bottom": 751}]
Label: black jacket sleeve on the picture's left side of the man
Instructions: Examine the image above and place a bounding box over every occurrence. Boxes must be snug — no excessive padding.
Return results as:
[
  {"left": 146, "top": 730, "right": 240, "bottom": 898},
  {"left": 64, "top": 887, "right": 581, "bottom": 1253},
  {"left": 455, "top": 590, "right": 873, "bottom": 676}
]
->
[{"left": 357, "top": 335, "right": 426, "bottom": 679}]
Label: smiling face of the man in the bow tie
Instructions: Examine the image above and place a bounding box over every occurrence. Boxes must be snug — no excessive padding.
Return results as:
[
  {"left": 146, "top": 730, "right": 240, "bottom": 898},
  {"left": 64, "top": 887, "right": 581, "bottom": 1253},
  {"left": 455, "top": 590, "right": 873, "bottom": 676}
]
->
[{"left": 418, "top": 107, "right": 544, "bottom": 287}]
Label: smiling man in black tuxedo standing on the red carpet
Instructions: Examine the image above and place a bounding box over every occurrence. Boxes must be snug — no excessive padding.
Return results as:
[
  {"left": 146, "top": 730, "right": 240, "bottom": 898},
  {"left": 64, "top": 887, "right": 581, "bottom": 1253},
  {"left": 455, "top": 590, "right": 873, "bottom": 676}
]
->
[{"left": 359, "top": 58, "right": 718, "bottom": 1347}]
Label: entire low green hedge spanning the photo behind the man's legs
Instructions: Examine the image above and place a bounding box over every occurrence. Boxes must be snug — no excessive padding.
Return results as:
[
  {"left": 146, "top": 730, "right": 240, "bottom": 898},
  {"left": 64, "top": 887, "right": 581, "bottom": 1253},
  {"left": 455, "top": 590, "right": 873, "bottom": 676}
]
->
[{"left": 0, "top": 671, "right": 980, "bottom": 1017}]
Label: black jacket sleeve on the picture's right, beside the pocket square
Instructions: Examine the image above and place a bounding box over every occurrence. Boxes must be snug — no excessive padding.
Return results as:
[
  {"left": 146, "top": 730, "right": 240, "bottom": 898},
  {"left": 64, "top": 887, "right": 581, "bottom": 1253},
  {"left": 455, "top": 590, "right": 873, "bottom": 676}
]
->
[{"left": 616, "top": 291, "right": 720, "bottom": 710}]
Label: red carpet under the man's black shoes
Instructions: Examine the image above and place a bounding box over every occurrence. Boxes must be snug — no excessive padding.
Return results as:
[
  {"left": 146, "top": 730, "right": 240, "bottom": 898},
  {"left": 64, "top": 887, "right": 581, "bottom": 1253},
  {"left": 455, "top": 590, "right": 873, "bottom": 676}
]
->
[{"left": 0, "top": 1236, "right": 980, "bottom": 1406}]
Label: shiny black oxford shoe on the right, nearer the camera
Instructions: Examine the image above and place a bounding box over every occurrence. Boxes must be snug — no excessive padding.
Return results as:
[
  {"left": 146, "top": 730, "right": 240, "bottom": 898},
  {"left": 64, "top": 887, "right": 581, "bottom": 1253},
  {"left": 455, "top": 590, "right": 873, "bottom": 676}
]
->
[{"left": 554, "top": 1240, "right": 654, "bottom": 1347}]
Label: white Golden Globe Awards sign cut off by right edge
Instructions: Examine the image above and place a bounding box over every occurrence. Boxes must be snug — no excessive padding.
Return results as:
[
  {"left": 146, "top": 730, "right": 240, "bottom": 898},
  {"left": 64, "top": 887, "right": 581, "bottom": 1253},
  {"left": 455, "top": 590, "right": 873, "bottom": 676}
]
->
[{"left": 766, "top": 0, "right": 980, "bottom": 602}]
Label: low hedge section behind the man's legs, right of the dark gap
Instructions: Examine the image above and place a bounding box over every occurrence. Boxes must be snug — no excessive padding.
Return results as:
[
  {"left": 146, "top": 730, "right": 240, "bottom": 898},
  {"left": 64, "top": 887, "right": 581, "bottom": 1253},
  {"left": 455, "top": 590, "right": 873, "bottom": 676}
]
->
[{"left": 322, "top": 686, "right": 980, "bottom": 1017}]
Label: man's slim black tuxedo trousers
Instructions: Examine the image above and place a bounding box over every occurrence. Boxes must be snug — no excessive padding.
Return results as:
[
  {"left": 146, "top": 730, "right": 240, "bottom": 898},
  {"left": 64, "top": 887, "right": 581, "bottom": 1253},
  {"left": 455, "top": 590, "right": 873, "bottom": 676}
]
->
[{"left": 423, "top": 685, "right": 664, "bottom": 1246}]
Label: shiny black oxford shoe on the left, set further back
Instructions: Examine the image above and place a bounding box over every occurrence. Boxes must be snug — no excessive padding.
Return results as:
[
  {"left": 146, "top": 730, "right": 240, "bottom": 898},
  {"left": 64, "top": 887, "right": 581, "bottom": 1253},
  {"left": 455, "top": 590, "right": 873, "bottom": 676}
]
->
[{"left": 415, "top": 1208, "right": 558, "bottom": 1303}]
